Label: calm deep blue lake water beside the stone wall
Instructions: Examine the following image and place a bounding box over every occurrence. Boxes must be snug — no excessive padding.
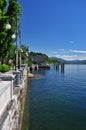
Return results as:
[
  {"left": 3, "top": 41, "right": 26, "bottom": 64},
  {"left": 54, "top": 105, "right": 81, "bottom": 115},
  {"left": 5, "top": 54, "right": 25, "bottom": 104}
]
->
[{"left": 24, "top": 65, "right": 86, "bottom": 130}]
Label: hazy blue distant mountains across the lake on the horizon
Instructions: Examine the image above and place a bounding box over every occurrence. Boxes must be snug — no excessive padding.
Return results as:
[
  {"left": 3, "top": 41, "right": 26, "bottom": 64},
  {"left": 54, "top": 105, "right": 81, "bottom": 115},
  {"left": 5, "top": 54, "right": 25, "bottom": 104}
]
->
[{"left": 50, "top": 57, "right": 86, "bottom": 64}]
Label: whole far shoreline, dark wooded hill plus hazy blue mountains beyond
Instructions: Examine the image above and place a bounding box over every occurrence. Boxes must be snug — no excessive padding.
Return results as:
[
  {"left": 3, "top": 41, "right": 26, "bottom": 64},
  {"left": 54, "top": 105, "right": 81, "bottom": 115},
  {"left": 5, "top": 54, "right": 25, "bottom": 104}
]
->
[{"left": 28, "top": 52, "right": 86, "bottom": 65}]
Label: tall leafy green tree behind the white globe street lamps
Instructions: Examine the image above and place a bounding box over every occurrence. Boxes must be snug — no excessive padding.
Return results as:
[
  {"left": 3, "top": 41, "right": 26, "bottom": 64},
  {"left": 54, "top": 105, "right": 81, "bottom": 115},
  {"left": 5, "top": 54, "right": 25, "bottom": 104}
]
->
[{"left": 0, "top": 0, "right": 21, "bottom": 64}]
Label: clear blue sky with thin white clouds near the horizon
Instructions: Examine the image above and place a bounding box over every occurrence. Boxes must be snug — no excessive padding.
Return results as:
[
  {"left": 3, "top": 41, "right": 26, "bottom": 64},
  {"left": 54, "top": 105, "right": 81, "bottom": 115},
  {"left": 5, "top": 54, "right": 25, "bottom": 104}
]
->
[{"left": 19, "top": 0, "right": 86, "bottom": 60}]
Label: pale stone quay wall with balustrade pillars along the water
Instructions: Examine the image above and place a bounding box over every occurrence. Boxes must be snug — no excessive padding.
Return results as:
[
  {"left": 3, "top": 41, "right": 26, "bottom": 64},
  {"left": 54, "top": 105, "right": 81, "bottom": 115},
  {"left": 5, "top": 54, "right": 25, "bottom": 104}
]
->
[{"left": 0, "top": 64, "right": 27, "bottom": 130}]
